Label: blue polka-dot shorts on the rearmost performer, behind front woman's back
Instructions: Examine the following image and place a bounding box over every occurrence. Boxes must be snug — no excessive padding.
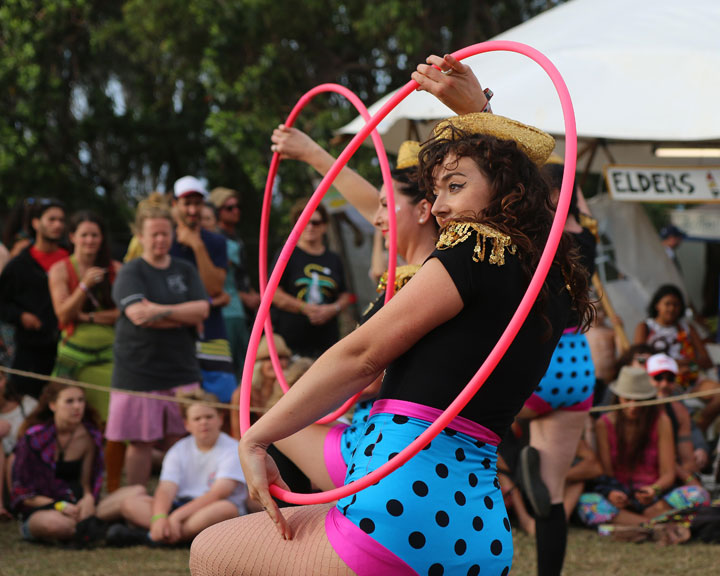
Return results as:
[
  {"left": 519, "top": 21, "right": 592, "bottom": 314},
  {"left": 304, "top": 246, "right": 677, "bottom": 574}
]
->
[{"left": 529, "top": 333, "right": 595, "bottom": 412}]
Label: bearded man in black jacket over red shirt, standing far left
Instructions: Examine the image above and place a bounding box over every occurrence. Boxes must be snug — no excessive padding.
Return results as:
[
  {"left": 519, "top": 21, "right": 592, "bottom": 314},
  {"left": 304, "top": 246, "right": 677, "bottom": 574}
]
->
[{"left": 0, "top": 198, "right": 68, "bottom": 398}]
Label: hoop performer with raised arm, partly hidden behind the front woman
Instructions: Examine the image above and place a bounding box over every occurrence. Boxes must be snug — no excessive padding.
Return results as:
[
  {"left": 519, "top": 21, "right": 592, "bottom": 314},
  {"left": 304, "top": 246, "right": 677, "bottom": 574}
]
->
[{"left": 264, "top": 57, "right": 490, "bottom": 490}]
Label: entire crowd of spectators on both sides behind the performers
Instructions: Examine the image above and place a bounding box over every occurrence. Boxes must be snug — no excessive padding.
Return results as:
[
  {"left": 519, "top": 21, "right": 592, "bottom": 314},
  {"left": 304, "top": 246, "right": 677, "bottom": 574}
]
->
[{"left": 0, "top": 176, "right": 720, "bottom": 545}]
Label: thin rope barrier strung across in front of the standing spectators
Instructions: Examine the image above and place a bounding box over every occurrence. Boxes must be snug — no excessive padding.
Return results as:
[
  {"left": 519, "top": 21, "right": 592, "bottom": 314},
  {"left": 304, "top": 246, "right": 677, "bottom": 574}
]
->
[{"left": 0, "top": 366, "right": 720, "bottom": 414}]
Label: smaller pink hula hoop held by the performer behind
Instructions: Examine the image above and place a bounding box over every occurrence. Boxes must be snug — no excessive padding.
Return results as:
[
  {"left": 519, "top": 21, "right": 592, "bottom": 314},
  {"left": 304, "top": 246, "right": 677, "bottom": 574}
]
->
[{"left": 249, "top": 84, "right": 397, "bottom": 432}]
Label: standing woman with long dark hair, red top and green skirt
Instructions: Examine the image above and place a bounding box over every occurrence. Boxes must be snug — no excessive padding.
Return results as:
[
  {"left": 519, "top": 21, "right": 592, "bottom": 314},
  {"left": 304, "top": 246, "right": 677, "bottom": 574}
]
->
[{"left": 48, "top": 210, "right": 120, "bottom": 422}]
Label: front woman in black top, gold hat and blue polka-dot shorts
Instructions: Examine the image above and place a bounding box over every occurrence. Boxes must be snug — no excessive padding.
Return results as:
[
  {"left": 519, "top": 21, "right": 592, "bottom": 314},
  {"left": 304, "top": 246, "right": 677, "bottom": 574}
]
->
[{"left": 191, "top": 51, "right": 591, "bottom": 576}]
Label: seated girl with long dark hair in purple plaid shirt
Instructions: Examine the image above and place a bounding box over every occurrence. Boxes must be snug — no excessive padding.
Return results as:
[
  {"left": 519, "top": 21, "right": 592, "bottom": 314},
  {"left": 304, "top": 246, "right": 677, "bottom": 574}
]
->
[{"left": 11, "top": 382, "right": 139, "bottom": 542}]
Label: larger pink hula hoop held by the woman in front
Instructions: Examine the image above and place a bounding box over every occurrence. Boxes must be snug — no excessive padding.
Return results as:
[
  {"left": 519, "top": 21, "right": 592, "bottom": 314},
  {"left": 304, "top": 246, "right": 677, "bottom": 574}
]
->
[{"left": 243, "top": 41, "right": 577, "bottom": 504}]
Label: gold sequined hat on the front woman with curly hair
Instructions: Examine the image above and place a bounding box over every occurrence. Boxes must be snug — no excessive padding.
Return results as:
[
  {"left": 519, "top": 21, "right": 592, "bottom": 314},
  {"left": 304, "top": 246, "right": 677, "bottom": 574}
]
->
[{"left": 432, "top": 112, "right": 555, "bottom": 166}]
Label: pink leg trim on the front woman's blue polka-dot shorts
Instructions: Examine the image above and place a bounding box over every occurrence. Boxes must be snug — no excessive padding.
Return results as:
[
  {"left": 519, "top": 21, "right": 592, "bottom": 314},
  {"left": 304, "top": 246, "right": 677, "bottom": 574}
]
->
[{"left": 325, "top": 506, "right": 417, "bottom": 576}]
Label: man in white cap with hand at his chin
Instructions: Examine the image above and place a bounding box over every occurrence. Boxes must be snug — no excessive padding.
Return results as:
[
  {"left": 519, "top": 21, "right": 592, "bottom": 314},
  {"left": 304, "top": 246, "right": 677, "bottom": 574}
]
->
[{"left": 170, "top": 176, "right": 237, "bottom": 402}]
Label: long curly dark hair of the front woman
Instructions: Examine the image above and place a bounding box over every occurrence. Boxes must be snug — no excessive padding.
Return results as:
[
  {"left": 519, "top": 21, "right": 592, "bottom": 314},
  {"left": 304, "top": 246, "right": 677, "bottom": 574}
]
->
[{"left": 420, "top": 126, "right": 595, "bottom": 335}]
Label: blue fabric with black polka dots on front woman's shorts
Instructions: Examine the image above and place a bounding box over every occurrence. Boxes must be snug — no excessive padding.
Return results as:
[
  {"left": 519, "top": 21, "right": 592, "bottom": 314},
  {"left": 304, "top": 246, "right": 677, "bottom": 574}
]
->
[{"left": 336, "top": 412, "right": 513, "bottom": 576}]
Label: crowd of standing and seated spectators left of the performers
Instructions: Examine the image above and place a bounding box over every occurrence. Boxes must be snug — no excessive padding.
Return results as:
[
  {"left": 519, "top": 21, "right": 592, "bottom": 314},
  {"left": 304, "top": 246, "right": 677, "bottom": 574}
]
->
[{"left": 0, "top": 181, "right": 342, "bottom": 545}]
